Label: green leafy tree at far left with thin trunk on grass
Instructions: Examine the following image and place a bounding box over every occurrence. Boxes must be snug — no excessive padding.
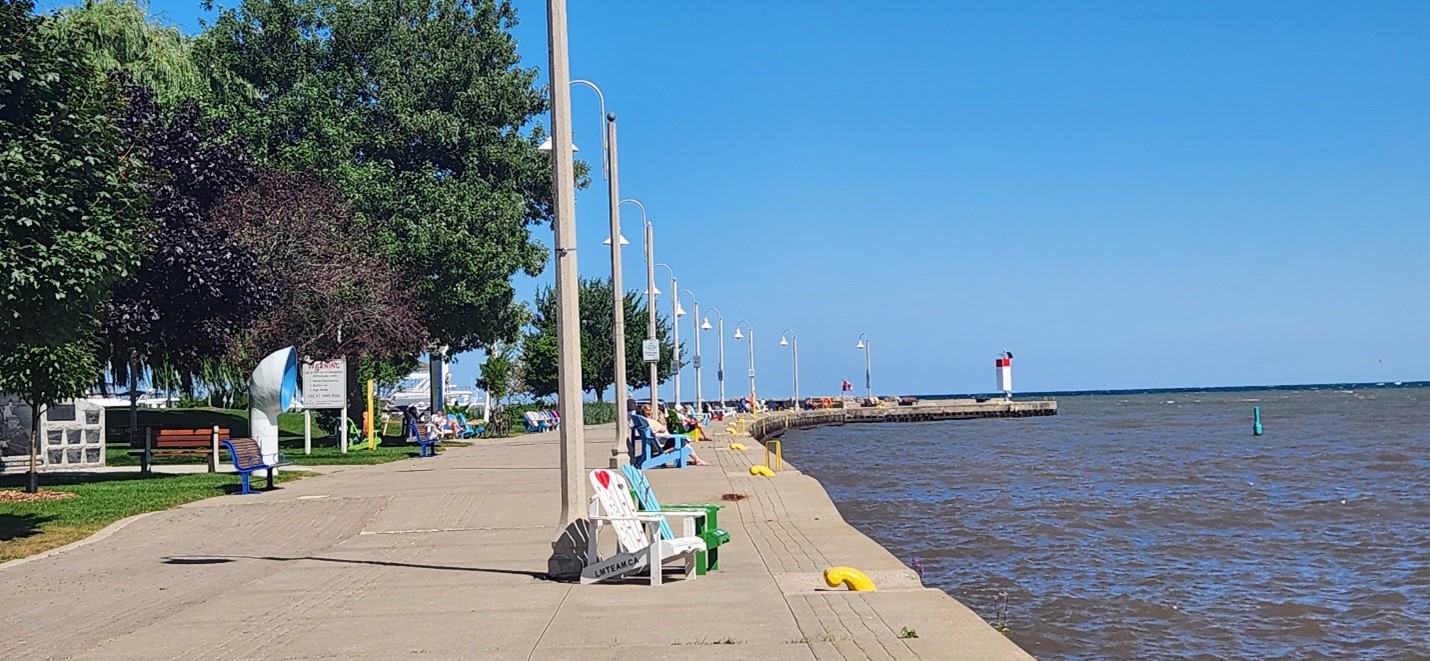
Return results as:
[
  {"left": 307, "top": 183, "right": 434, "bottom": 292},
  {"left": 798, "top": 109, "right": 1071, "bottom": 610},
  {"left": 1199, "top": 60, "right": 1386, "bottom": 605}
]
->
[{"left": 0, "top": 0, "right": 147, "bottom": 492}]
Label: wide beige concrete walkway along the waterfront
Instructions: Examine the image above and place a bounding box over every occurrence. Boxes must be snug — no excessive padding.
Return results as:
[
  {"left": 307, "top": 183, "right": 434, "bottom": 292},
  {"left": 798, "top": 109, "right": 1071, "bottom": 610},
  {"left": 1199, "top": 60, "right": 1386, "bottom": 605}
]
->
[{"left": 0, "top": 426, "right": 1031, "bottom": 660}]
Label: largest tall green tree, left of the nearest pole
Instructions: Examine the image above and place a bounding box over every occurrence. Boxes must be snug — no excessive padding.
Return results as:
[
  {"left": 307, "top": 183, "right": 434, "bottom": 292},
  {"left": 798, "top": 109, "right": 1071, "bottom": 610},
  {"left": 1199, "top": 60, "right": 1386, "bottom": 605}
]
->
[{"left": 196, "top": 0, "right": 569, "bottom": 353}]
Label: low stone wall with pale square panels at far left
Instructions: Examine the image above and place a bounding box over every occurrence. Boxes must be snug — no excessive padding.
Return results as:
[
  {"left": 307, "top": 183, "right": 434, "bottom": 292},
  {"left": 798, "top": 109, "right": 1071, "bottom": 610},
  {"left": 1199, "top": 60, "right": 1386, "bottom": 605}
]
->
[{"left": 0, "top": 396, "right": 104, "bottom": 472}]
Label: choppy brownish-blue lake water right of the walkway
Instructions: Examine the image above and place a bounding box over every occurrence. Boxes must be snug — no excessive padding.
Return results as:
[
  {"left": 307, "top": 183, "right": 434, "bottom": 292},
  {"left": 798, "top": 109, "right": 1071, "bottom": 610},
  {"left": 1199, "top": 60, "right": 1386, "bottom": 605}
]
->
[{"left": 784, "top": 388, "right": 1430, "bottom": 658}]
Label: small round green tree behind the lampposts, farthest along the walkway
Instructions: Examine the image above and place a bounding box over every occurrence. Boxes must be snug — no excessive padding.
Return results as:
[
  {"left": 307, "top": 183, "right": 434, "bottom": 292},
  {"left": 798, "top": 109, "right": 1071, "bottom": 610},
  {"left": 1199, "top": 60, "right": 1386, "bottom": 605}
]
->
[{"left": 522, "top": 278, "right": 675, "bottom": 401}]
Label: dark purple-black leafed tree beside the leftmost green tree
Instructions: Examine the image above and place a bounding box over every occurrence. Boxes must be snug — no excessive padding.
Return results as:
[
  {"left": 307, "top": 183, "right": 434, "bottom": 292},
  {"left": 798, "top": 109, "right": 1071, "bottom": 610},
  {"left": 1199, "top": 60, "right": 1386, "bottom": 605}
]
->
[{"left": 104, "top": 74, "right": 277, "bottom": 385}]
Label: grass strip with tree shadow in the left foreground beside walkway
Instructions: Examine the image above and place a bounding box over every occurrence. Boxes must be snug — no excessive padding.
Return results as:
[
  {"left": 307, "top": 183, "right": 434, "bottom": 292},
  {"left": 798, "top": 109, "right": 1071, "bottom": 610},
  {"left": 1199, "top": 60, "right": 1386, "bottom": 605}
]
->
[{"left": 0, "top": 472, "right": 312, "bottom": 562}]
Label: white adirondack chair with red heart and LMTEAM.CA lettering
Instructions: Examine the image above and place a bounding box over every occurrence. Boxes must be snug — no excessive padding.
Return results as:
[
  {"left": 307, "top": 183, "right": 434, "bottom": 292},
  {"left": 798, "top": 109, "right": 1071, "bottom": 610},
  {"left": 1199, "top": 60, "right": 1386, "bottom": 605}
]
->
[{"left": 581, "top": 469, "right": 705, "bottom": 585}]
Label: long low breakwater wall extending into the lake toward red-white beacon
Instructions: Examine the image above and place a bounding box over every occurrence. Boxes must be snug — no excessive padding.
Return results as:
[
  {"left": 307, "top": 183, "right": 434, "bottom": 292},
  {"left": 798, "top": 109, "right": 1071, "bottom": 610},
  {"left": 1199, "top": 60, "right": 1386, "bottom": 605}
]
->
[{"left": 749, "top": 399, "right": 1058, "bottom": 441}]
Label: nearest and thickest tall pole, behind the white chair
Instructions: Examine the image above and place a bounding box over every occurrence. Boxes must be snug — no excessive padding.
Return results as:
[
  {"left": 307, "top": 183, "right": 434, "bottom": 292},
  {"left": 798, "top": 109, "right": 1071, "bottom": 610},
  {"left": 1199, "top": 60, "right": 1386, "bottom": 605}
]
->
[{"left": 546, "top": 0, "right": 586, "bottom": 526}]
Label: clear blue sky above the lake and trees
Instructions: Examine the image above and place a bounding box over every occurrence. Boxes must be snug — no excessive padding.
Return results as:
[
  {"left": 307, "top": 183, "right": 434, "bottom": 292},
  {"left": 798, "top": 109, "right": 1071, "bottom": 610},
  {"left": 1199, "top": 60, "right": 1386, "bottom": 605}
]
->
[{"left": 61, "top": 1, "right": 1430, "bottom": 398}]
